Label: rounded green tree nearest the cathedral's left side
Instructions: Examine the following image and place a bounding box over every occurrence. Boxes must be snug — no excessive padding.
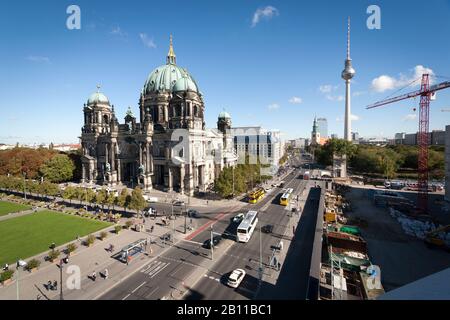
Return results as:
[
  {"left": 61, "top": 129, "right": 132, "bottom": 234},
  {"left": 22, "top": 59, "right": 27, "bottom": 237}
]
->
[{"left": 39, "top": 154, "right": 75, "bottom": 183}]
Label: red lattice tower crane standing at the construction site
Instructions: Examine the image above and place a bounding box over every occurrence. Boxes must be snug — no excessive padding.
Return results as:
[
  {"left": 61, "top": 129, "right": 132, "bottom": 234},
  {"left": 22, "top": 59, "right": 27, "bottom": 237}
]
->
[{"left": 366, "top": 74, "right": 450, "bottom": 213}]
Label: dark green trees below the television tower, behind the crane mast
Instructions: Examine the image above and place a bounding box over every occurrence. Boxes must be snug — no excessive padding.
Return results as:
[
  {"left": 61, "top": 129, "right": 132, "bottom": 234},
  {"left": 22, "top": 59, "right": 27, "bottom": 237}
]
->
[{"left": 311, "top": 139, "right": 445, "bottom": 179}]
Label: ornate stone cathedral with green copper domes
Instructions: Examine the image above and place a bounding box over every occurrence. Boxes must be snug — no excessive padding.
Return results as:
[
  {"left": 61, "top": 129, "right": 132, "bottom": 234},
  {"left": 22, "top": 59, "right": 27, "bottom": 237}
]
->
[{"left": 80, "top": 37, "right": 237, "bottom": 195}]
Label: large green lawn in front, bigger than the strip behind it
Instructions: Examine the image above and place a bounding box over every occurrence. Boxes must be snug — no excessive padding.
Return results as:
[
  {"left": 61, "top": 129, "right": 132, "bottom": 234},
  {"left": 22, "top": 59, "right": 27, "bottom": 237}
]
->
[{"left": 0, "top": 211, "right": 111, "bottom": 266}]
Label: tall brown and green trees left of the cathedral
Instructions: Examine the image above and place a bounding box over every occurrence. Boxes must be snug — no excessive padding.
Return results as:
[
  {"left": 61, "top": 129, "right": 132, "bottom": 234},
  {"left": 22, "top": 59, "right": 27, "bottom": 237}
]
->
[{"left": 0, "top": 147, "right": 81, "bottom": 183}]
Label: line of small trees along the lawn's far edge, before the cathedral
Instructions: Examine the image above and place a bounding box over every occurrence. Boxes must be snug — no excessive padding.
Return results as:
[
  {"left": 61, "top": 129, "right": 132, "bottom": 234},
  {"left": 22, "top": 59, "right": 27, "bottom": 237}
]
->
[{"left": 0, "top": 176, "right": 147, "bottom": 213}]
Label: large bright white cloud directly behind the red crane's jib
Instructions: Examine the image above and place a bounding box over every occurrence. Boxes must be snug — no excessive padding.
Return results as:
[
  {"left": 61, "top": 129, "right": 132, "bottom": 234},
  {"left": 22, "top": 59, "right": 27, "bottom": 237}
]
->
[{"left": 372, "top": 65, "right": 434, "bottom": 92}]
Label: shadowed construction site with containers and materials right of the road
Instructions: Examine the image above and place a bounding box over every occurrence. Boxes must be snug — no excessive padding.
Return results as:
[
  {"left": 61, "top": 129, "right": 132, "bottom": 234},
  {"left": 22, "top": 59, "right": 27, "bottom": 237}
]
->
[{"left": 320, "top": 183, "right": 450, "bottom": 300}]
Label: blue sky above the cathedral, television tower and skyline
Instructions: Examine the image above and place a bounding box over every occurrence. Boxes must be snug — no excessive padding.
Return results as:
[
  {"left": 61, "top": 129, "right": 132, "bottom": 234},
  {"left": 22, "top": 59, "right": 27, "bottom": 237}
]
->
[{"left": 0, "top": 0, "right": 450, "bottom": 143}]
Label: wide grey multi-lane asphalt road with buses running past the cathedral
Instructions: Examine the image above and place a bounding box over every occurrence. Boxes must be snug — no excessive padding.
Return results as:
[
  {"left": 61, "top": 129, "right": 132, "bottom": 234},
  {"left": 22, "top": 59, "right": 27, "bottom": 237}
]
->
[{"left": 100, "top": 153, "right": 322, "bottom": 300}]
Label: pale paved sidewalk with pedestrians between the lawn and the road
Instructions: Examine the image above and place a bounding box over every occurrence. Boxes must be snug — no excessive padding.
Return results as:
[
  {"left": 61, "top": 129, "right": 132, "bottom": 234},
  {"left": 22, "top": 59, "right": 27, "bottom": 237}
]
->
[{"left": 0, "top": 212, "right": 193, "bottom": 300}]
